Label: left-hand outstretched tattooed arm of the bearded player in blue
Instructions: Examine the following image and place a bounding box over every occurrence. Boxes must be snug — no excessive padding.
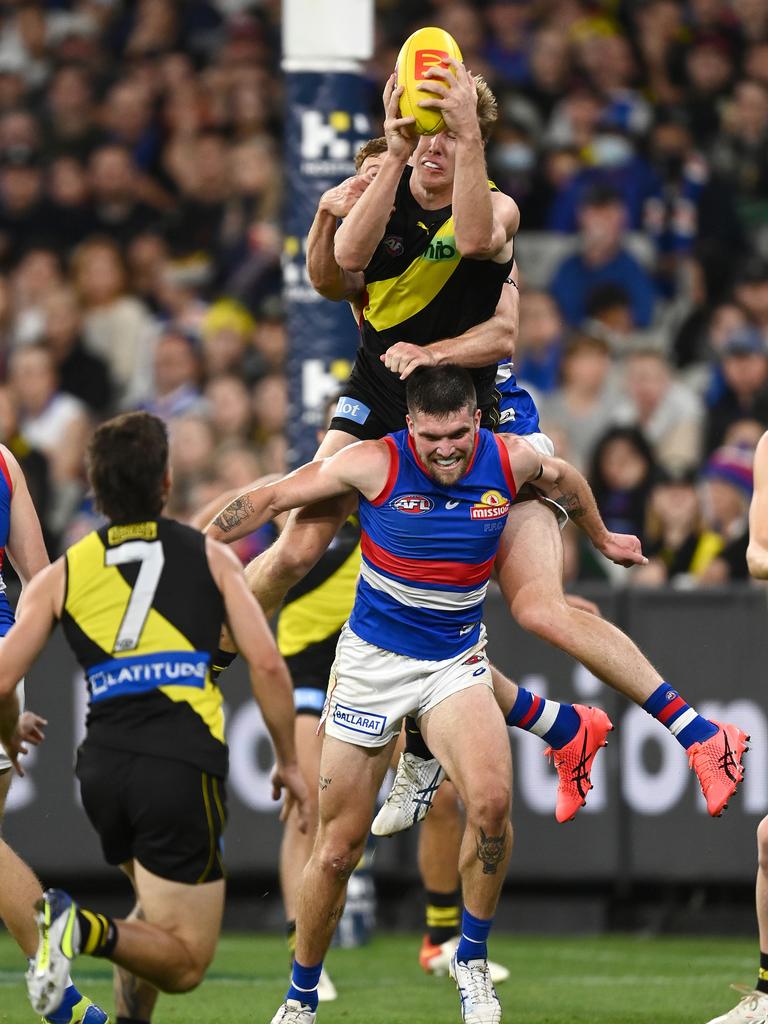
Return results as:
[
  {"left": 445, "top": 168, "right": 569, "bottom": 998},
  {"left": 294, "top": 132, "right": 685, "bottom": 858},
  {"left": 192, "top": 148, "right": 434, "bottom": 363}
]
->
[{"left": 205, "top": 441, "right": 389, "bottom": 544}]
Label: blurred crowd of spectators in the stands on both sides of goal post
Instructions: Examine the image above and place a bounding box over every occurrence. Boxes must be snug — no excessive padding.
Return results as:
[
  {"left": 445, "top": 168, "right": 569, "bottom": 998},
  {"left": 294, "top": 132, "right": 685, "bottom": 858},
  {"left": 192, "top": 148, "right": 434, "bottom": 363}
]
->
[{"left": 0, "top": 0, "right": 768, "bottom": 586}]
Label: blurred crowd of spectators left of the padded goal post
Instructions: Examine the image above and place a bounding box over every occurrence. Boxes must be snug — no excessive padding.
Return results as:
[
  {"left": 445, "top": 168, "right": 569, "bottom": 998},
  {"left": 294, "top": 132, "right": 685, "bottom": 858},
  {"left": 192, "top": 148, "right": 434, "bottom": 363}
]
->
[{"left": 0, "top": 0, "right": 287, "bottom": 569}]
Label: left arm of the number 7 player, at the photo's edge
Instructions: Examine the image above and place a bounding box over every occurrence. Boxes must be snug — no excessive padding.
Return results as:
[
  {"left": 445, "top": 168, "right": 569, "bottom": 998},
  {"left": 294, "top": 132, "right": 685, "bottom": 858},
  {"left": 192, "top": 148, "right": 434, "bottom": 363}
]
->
[{"left": 0, "top": 558, "right": 65, "bottom": 775}]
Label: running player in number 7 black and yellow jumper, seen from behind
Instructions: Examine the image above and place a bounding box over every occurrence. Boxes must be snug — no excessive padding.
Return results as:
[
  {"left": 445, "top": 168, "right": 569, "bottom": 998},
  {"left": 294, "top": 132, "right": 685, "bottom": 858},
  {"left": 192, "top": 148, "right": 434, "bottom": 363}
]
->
[{"left": 0, "top": 413, "right": 306, "bottom": 1022}]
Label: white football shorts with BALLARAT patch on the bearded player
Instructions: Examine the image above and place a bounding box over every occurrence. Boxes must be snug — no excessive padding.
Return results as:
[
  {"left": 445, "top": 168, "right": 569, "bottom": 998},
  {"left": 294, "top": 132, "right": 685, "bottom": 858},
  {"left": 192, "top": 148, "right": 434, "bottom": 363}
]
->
[{"left": 323, "top": 625, "right": 494, "bottom": 746}]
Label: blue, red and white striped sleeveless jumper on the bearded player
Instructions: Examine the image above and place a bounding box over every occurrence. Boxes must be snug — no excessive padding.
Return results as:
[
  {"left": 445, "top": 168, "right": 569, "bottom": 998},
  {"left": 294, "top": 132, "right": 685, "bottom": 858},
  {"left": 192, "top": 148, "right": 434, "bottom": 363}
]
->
[{"left": 349, "top": 430, "right": 516, "bottom": 662}]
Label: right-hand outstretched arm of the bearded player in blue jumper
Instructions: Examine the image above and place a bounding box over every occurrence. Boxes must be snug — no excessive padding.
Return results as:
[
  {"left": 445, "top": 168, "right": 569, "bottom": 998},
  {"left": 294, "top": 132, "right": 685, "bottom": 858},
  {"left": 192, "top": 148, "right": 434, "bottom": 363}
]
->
[{"left": 500, "top": 434, "right": 648, "bottom": 568}]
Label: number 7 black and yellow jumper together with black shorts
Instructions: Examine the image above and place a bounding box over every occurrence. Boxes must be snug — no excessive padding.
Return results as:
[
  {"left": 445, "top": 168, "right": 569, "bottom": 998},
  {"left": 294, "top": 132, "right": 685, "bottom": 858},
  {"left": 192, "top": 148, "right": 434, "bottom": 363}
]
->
[{"left": 61, "top": 518, "right": 228, "bottom": 883}]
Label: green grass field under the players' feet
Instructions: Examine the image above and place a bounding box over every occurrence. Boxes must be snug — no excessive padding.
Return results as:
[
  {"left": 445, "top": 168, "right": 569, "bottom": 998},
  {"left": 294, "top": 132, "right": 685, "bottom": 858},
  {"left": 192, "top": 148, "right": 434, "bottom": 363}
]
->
[{"left": 0, "top": 934, "right": 757, "bottom": 1024}]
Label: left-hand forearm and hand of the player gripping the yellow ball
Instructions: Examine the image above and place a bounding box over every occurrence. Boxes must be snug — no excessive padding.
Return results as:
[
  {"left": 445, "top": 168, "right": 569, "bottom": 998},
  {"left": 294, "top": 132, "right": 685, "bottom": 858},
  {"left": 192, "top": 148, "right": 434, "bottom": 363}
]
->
[{"left": 334, "top": 75, "right": 418, "bottom": 271}]
